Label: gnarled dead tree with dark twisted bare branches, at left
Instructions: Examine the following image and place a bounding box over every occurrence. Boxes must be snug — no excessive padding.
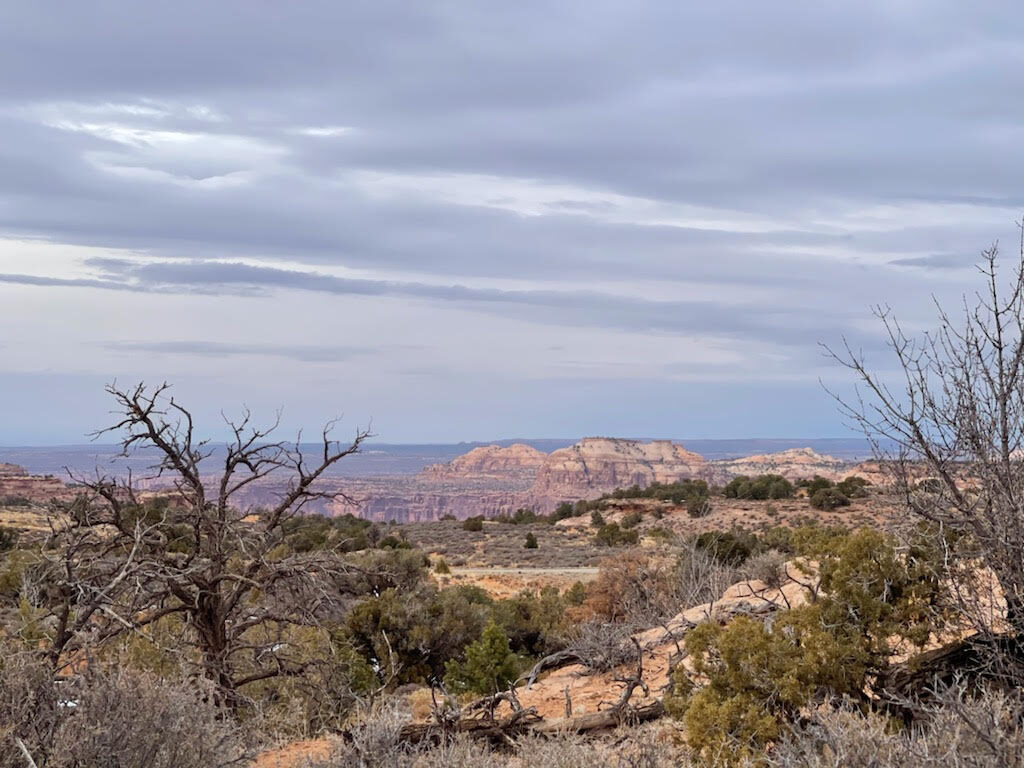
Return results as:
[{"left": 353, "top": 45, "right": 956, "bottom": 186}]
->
[{"left": 29, "top": 384, "right": 369, "bottom": 706}]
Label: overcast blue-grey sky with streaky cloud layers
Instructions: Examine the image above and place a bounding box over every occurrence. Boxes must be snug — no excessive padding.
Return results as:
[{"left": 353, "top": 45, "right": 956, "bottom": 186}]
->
[{"left": 0, "top": 0, "right": 1024, "bottom": 445}]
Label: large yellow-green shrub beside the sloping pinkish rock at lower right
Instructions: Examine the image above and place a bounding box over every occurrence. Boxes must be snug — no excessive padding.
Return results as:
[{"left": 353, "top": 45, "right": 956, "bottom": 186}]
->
[{"left": 670, "top": 528, "right": 940, "bottom": 765}]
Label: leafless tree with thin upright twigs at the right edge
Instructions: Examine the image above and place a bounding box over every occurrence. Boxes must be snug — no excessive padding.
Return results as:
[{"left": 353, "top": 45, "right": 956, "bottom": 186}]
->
[{"left": 829, "top": 241, "right": 1024, "bottom": 675}]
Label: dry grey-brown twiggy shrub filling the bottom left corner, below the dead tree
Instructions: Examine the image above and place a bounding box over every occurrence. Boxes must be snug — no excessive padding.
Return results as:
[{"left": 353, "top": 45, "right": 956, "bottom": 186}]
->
[{"left": 0, "top": 657, "right": 248, "bottom": 768}]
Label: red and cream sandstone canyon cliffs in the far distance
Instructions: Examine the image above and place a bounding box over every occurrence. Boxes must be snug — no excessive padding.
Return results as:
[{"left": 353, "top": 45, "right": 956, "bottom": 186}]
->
[{"left": 0, "top": 437, "right": 855, "bottom": 523}]
